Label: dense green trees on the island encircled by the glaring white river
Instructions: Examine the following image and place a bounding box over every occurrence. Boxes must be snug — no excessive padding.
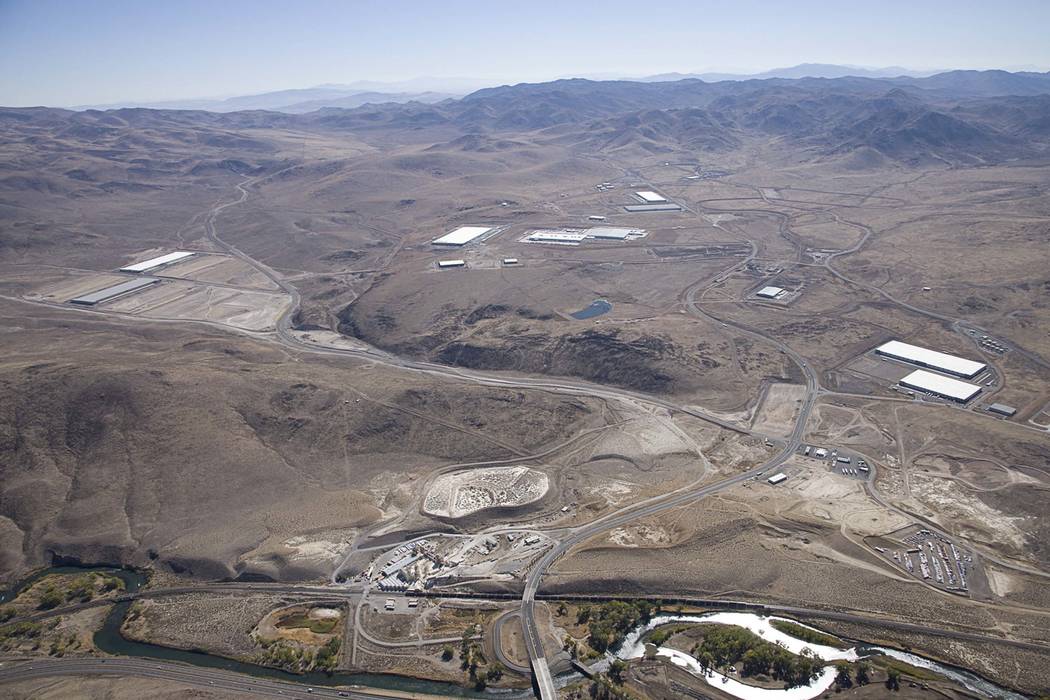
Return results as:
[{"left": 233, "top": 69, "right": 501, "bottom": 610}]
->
[{"left": 693, "top": 627, "right": 824, "bottom": 687}]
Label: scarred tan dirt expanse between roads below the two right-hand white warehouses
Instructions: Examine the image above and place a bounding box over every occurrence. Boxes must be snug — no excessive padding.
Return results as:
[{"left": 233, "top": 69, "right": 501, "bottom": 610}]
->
[{"left": 806, "top": 397, "right": 1050, "bottom": 565}]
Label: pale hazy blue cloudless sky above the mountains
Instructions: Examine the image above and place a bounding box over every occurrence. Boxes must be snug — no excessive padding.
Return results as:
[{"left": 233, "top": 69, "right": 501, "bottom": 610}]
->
[{"left": 0, "top": 0, "right": 1050, "bottom": 106}]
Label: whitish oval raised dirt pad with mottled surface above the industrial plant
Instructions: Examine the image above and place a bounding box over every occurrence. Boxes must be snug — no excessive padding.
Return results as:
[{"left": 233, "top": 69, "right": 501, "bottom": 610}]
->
[{"left": 423, "top": 466, "right": 549, "bottom": 518}]
